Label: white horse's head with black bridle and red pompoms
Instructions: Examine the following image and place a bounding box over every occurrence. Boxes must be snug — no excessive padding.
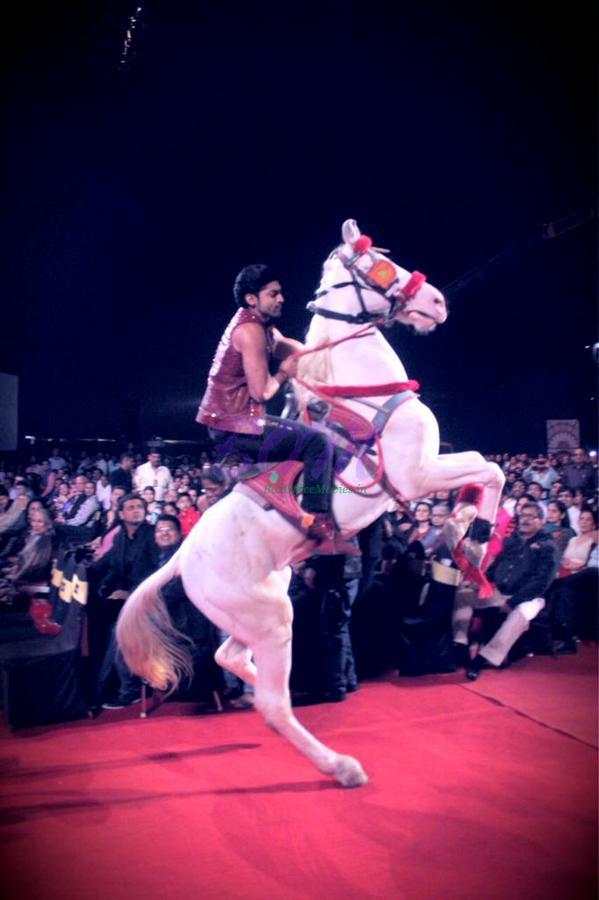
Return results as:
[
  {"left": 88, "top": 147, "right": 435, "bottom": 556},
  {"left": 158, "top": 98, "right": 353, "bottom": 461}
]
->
[{"left": 316, "top": 219, "right": 447, "bottom": 334}]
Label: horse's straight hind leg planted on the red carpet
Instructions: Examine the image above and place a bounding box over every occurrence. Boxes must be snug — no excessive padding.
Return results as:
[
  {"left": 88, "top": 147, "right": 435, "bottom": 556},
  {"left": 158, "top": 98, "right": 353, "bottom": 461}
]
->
[{"left": 253, "top": 624, "right": 368, "bottom": 787}]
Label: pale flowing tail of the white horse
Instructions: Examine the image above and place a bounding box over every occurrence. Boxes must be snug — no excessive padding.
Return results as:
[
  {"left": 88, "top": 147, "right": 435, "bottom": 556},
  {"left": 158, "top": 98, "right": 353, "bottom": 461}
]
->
[{"left": 116, "top": 552, "right": 193, "bottom": 691}]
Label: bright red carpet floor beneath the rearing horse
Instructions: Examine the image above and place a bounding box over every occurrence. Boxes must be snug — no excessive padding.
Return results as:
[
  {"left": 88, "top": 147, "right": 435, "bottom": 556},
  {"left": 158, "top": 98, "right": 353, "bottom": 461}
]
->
[{"left": 0, "top": 645, "right": 597, "bottom": 900}]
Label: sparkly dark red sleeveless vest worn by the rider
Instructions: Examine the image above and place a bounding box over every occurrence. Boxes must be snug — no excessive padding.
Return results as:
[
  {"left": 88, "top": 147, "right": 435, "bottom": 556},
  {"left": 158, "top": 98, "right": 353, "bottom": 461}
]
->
[{"left": 196, "top": 307, "right": 274, "bottom": 434}]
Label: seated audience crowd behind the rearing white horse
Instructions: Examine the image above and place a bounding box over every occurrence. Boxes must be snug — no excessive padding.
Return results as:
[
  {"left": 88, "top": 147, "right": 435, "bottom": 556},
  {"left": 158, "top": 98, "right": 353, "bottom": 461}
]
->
[{"left": 0, "top": 443, "right": 599, "bottom": 724}]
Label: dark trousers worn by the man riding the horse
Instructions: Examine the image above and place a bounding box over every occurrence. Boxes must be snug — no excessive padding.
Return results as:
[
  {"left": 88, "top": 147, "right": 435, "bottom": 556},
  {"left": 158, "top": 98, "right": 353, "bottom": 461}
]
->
[{"left": 208, "top": 416, "right": 333, "bottom": 513}]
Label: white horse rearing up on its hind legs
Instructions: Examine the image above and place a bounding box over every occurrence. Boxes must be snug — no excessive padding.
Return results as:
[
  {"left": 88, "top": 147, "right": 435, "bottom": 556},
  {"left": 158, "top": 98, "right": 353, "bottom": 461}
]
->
[{"left": 117, "top": 220, "right": 503, "bottom": 787}]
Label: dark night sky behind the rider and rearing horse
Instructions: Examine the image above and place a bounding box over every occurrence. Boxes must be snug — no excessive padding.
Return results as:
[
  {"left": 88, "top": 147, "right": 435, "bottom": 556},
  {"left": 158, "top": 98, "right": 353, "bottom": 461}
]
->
[{"left": 0, "top": 0, "right": 597, "bottom": 452}]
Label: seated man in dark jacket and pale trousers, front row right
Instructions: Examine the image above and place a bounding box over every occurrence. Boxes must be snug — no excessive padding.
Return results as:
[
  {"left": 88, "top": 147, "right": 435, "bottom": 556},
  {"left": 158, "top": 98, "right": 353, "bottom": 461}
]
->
[{"left": 452, "top": 502, "right": 558, "bottom": 681}]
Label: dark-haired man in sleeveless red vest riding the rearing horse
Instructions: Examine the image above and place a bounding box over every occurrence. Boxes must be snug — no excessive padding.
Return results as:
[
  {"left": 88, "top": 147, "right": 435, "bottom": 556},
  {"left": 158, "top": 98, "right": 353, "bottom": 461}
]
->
[{"left": 196, "top": 264, "right": 356, "bottom": 554}]
